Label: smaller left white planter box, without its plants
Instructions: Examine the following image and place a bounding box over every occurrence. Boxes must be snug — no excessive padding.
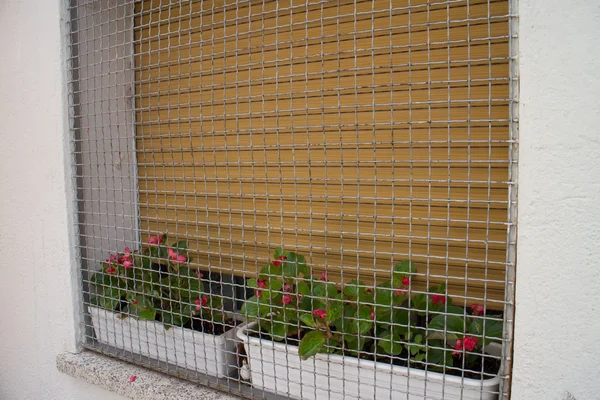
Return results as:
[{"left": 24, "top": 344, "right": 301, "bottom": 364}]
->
[{"left": 88, "top": 307, "right": 237, "bottom": 377}]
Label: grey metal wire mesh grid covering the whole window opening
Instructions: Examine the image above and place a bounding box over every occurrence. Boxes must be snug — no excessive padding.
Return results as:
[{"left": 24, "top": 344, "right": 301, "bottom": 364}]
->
[{"left": 66, "top": 0, "right": 518, "bottom": 399}]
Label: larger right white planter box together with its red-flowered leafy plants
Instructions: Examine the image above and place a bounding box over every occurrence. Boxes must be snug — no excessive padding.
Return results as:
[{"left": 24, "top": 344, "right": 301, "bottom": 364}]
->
[{"left": 238, "top": 248, "right": 502, "bottom": 400}]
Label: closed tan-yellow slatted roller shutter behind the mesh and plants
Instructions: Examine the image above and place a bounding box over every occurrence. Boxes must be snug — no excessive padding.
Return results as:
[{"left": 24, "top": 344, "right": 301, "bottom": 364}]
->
[{"left": 135, "top": 0, "right": 509, "bottom": 308}]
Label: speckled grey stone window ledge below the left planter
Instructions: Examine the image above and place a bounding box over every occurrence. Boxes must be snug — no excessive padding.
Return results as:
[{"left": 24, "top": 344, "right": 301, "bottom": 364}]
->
[{"left": 56, "top": 351, "right": 240, "bottom": 400}]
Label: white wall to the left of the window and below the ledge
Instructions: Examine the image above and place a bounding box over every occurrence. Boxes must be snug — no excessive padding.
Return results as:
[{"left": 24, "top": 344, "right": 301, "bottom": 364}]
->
[{"left": 0, "top": 0, "right": 122, "bottom": 400}]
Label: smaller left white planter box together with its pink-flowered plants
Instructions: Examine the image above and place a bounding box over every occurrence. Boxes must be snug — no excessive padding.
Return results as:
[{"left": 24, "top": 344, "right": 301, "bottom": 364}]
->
[{"left": 89, "top": 235, "right": 237, "bottom": 377}]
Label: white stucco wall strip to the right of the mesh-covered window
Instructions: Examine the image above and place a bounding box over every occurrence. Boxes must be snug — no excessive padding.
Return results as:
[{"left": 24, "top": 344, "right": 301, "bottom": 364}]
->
[{"left": 512, "top": 0, "right": 600, "bottom": 400}]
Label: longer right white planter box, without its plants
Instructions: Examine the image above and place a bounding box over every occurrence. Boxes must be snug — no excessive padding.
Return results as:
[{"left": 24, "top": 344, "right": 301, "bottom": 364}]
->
[{"left": 237, "top": 324, "right": 500, "bottom": 400}]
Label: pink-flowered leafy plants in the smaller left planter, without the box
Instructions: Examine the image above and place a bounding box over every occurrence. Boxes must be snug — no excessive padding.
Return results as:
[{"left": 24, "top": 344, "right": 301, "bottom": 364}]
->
[{"left": 90, "top": 234, "right": 225, "bottom": 330}]
